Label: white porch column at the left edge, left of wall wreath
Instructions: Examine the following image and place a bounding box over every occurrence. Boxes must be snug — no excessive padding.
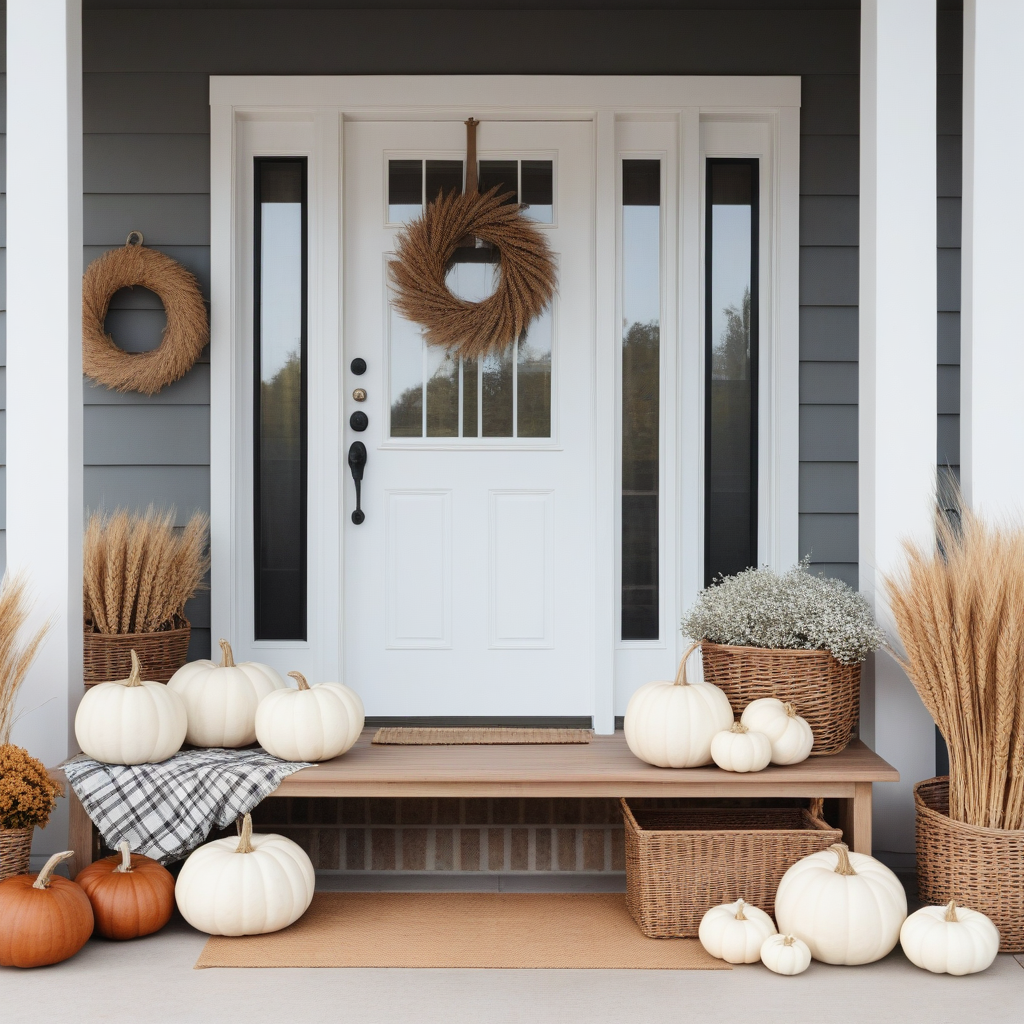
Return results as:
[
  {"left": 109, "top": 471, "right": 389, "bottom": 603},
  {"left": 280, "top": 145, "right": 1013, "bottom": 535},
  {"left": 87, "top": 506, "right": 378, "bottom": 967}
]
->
[{"left": 7, "top": 0, "right": 83, "bottom": 850}]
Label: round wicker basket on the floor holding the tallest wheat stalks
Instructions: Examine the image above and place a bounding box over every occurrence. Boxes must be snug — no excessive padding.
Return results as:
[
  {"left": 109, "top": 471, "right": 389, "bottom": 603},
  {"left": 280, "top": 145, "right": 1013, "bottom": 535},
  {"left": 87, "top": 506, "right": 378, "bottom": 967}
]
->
[{"left": 913, "top": 775, "right": 1024, "bottom": 953}]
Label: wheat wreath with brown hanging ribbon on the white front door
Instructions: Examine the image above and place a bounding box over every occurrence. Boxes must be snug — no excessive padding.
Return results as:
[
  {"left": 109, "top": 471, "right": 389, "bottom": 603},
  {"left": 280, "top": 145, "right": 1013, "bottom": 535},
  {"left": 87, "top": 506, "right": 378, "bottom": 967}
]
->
[{"left": 389, "top": 118, "right": 556, "bottom": 359}]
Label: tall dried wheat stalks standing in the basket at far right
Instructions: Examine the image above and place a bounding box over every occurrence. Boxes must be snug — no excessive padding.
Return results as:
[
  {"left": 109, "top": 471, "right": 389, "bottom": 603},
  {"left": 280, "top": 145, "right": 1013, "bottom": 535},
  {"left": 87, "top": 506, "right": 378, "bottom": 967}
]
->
[{"left": 886, "top": 510, "right": 1024, "bottom": 828}]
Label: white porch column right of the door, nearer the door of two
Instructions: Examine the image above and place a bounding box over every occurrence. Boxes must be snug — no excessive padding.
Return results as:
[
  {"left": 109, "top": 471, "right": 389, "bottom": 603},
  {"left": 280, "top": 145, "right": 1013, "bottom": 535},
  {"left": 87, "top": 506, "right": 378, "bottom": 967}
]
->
[{"left": 859, "top": 0, "right": 937, "bottom": 854}]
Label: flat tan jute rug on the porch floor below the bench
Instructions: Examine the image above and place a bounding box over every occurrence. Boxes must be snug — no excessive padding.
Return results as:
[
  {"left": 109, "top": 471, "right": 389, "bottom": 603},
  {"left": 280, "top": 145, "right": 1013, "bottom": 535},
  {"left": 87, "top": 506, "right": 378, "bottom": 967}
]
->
[{"left": 196, "top": 893, "right": 731, "bottom": 971}]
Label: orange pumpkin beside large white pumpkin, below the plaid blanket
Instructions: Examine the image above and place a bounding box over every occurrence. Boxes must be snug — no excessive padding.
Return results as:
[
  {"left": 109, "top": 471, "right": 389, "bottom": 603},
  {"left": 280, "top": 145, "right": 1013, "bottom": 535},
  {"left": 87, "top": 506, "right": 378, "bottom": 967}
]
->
[{"left": 75, "top": 841, "right": 174, "bottom": 939}]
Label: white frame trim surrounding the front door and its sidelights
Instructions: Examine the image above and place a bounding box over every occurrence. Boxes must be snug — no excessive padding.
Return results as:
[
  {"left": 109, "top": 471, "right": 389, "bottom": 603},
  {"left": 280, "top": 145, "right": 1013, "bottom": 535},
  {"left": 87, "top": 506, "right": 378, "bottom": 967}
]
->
[{"left": 210, "top": 76, "right": 800, "bottom": 732}]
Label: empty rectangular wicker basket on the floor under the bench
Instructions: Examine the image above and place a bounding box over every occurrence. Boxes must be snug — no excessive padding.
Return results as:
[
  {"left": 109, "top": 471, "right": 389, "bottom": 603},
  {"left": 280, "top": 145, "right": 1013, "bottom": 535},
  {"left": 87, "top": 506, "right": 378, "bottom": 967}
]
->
[{"left": 622, "top": 800, "right": 843, "bottom": 939}]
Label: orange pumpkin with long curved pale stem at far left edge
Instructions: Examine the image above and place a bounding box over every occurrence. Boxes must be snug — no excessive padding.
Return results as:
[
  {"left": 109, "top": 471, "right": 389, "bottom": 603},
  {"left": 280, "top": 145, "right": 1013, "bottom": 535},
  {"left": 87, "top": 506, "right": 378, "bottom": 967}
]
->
[{"left": 0, "top": 850, "right": 92, "bottom": 967}]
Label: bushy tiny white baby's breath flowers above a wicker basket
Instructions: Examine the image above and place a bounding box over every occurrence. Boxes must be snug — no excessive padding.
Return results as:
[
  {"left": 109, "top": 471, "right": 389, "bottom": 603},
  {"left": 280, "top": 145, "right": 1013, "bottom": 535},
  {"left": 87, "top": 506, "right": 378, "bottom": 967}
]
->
[{"left": 682, "top": 558, "right": 886, "bottom": 665}]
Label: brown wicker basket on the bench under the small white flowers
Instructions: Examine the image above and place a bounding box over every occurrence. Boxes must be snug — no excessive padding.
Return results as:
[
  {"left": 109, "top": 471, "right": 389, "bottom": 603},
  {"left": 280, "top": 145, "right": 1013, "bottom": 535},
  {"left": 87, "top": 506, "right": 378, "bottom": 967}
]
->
[{"left": 700, "top": 641, "right": 860, "bottom": 757}]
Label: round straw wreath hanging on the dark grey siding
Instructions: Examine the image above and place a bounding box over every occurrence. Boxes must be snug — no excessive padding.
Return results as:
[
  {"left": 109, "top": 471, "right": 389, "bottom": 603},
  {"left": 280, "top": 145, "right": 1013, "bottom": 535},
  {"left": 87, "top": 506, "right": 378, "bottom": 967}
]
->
[{"left": 82, "top": 231, "right": 210, "bottom": 394}]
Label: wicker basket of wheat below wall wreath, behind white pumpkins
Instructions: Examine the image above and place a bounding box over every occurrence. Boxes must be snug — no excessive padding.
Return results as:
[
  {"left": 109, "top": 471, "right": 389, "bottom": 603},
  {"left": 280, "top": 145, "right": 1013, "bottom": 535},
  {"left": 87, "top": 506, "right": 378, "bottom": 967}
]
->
[{"left": 84, "top": 507, "right": 210, "bottom": 684}]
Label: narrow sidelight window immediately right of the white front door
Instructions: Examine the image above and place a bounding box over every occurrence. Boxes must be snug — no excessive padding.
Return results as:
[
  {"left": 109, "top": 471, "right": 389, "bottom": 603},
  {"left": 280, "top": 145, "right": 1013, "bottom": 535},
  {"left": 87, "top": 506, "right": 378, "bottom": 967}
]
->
[{"left": 622, "top": 160, "right": 662, "bottom": 640}]
